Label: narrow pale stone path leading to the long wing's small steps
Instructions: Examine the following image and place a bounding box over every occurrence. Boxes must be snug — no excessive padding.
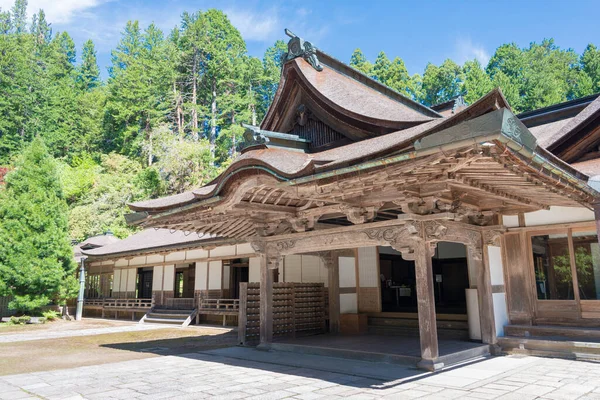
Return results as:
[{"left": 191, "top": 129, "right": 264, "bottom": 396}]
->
[{"left": 0, "top": 323, "right": 173, "bottom": 343}]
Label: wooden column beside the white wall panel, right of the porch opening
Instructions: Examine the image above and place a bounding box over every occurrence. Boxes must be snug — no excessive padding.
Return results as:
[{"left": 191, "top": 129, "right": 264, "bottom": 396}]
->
[{"left": 474, "top": 245, "right": 497, "bottom": 344}]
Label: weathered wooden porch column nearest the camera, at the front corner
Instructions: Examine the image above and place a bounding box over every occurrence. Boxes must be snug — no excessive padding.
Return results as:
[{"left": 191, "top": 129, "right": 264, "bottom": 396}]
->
[{"left": 414, "top": 240, "right": 444, "bottom": 371}]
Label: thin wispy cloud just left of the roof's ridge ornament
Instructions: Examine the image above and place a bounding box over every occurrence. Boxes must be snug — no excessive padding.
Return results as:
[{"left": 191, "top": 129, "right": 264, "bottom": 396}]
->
[{"left": 225, "top": 9, "right": 281, "bottom": 42}]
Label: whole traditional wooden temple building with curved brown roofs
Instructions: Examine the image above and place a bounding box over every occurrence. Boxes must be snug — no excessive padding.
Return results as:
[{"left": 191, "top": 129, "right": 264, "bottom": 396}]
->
[{"left": 84, "top": 31, "right": 600, "bottom": 370}]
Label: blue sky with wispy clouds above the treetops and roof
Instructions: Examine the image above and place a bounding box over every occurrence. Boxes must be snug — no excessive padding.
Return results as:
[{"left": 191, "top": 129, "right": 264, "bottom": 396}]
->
[{"left": 0, "top": 0, "right": 600, "bottom": 76}]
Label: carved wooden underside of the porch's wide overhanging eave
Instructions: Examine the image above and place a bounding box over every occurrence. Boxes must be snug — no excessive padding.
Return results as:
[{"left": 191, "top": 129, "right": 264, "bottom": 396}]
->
[{"left": 129, "top": 109, "right": 598, "bottom": 238}]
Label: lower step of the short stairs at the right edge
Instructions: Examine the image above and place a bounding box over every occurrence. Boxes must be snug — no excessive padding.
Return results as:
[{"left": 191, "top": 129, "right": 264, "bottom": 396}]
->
[{"left": 498, "top": 336, "right": 600, "bottom": 361}]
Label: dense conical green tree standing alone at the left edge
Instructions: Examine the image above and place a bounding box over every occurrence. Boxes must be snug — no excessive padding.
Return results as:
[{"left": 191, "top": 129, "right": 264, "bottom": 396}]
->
[{"left": 0, "top": 137, "right": 77, "bottom": 312}]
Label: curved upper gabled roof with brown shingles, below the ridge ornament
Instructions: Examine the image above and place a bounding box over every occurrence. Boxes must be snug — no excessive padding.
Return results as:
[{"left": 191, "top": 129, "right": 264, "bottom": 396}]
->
[{"left": 261, "top": 51, "right": 442, "bottom": 140}]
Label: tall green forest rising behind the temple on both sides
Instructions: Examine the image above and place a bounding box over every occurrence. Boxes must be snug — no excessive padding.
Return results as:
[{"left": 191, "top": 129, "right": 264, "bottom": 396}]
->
[{"left": 0, "top": 0, "right": 600, "bottom": 245}]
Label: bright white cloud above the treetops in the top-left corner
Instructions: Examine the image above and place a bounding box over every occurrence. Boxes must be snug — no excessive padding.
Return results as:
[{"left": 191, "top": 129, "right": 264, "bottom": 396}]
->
[{"left": 0, "top": 0, "right": 110, "bottom": 24}]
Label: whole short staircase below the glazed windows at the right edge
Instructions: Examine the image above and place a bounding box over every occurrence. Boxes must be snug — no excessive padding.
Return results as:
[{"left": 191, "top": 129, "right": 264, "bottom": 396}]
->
[{"left": 498, "top": 325, "right": 600, "bottom": 361}]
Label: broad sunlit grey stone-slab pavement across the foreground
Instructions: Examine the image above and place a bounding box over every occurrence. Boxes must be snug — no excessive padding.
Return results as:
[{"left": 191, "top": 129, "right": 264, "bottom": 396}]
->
[{"left": 0, "top": 346, "right": 600, "bottom": 400}]
